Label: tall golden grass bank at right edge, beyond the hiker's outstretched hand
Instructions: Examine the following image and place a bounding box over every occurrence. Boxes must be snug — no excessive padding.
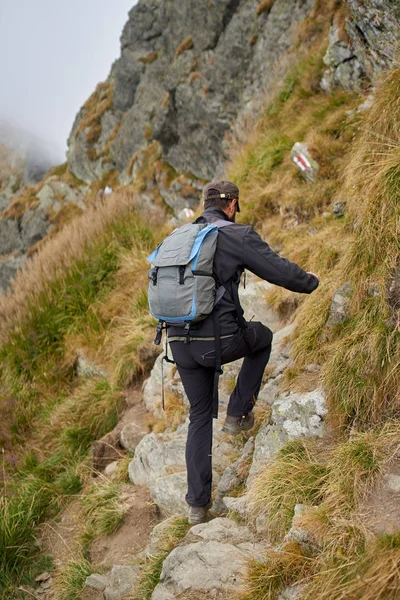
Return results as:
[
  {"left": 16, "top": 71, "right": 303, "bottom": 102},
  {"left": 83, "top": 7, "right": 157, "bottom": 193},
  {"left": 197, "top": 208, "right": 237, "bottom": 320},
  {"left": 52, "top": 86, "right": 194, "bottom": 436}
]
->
[{"left": 294, "top": 70, "right": 400, "bottom": 426}]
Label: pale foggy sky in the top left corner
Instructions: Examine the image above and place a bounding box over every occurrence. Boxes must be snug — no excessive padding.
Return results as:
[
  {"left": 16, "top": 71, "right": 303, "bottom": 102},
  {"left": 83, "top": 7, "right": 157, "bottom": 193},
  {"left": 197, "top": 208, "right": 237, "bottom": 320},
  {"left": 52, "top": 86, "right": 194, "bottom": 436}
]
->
[{"left": 0, "top": 0, "right": 136, "bottom": 160}]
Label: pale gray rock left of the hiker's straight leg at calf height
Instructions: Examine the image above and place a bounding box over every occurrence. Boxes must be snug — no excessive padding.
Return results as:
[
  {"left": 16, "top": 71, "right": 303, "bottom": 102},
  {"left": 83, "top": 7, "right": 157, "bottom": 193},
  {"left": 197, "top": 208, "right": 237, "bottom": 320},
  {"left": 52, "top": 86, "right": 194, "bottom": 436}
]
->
[{"left": 129, "top": 433, "right": 186, "bottom": 486}]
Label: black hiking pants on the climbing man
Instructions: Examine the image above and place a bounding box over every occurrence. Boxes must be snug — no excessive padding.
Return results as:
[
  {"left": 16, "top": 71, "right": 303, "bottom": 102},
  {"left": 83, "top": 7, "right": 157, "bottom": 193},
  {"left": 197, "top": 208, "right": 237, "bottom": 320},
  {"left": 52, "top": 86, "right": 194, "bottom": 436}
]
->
[{"left": 170, "top": 321, "right": 272, "bottom": 506}]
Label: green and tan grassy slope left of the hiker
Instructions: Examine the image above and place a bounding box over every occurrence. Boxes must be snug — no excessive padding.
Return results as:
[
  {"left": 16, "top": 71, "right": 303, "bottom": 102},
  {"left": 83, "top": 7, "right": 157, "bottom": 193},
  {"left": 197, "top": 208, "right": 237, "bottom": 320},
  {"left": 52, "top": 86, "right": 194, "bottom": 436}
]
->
[{"left": 0, "top": 194, "right": 166, "bottom": 598}]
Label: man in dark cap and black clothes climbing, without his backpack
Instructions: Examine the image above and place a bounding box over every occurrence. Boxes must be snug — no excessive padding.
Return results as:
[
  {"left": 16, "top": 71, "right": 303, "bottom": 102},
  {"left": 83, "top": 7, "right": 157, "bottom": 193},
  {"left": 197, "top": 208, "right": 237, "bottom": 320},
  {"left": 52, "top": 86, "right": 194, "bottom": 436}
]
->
[{"left": 168, "top": 181, "right": 319, "bottom": 524}]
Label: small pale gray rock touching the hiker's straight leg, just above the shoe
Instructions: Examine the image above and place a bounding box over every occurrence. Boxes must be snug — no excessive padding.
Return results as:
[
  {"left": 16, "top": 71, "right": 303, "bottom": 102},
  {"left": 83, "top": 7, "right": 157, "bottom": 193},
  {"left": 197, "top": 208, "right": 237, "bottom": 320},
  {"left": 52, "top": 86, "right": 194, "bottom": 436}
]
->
[{"left": 150, "top": 471, "right": 188, "bottom": 516}]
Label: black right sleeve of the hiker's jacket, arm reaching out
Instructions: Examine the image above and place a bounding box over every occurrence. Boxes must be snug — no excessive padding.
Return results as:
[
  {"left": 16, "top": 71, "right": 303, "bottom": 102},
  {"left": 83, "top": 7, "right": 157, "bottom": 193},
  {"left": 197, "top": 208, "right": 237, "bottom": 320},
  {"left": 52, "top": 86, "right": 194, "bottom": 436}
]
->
[{"left": 243, "top": 227, "right": 319, "bottom": 294}]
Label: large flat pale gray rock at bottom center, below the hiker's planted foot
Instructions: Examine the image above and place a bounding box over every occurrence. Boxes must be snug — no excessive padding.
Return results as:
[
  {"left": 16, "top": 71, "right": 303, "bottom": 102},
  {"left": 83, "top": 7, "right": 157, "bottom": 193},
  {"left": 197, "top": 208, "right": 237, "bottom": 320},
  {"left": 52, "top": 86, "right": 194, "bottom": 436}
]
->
[{"left": 152, "top": 541, "right": 250, "bottom": 600}]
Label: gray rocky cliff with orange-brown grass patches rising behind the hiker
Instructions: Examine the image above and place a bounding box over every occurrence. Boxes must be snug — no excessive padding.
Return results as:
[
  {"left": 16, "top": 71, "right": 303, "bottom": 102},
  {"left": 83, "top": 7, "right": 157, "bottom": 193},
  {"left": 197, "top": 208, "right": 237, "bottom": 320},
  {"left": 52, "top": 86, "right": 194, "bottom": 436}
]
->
[{"left": 0, "top": 0, "right": 399, "bottom": 292}]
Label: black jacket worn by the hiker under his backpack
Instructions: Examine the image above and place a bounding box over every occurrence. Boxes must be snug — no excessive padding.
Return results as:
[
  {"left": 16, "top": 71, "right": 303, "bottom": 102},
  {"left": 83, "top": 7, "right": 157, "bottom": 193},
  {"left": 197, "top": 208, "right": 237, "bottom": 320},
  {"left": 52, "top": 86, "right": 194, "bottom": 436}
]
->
[{"left": 168, "top": 206, "right": 319, "bottom": 337}]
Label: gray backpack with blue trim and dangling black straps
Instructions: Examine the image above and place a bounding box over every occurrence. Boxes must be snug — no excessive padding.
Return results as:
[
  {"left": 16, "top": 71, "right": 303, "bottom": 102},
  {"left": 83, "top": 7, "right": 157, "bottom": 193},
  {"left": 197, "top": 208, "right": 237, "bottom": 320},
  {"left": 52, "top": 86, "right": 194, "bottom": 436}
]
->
[{"left": 147, "top": 219, "right": 232, "bottom": 418}]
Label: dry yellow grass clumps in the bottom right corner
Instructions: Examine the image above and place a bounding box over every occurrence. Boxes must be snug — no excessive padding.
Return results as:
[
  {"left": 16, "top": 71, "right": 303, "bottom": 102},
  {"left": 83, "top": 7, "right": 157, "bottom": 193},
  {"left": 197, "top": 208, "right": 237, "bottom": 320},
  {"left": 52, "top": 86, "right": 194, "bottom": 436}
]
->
[{"left": 245, "top": 422, "right": 400, "bottom": 600}]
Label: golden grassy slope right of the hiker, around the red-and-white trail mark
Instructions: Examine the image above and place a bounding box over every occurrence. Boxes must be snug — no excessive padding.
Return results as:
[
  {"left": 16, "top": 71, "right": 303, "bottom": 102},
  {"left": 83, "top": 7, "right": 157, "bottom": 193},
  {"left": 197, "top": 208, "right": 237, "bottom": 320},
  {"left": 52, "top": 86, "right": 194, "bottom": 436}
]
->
[{"left": 229, "top": 23, "right": 400, "bottom": 600}]
